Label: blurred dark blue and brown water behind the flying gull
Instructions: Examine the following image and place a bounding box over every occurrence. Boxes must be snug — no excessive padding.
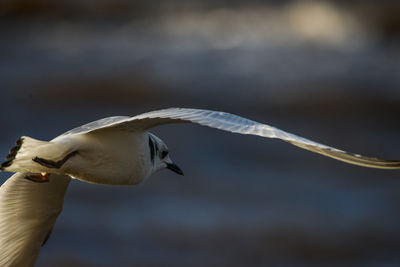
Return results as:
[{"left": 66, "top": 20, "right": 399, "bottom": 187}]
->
[{"left": 0, "top": 0, "right": 400, "bottom": 266}]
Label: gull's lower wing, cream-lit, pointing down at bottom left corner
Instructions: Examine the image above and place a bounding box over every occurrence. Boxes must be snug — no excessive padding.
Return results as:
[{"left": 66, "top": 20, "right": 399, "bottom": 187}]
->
[{"left": 0, "top": 173, "right": 71, "bottom": 266}]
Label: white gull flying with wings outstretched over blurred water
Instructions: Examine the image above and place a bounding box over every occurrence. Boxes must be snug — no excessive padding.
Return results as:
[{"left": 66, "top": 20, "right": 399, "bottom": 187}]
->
[{"left": 0, "top": 108, "right": 400, "bottom": 266}]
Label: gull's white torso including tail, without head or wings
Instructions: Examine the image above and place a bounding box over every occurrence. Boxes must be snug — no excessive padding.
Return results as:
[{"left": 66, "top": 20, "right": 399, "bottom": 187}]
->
[{"left": 3, "top": 129, "right": 160, "bottom": 185}]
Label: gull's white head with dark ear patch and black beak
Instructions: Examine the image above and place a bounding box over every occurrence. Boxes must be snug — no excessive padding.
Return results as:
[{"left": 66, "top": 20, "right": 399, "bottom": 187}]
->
[{"left": 149, "top": 133, "right": 183, "bottom": 175}]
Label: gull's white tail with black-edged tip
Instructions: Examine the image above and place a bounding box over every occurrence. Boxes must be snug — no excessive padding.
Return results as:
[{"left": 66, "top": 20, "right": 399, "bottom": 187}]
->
[{"left": 0, "top": 136, "right": 70, "bottom": 173}]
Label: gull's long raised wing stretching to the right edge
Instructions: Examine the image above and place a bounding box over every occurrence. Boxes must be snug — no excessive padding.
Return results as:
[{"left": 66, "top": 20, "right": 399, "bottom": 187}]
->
[{"left": 65, "top": 108, "right": 400, "bottom": 169}]
